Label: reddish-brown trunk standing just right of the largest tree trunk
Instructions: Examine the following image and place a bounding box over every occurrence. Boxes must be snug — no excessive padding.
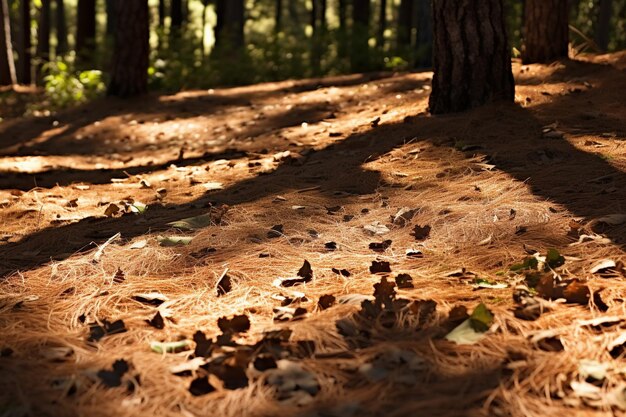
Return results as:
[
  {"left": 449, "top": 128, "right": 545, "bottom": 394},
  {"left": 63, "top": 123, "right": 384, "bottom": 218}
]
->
[{"left": 522, "top": 0, "right": 569, "bottom": 64}]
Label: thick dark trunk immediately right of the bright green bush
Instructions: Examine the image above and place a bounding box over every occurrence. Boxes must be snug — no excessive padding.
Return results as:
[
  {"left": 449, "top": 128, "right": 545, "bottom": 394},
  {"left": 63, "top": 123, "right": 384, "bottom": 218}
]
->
[{"left": 107, "top": 0, "right": 150, "bottom": 97}]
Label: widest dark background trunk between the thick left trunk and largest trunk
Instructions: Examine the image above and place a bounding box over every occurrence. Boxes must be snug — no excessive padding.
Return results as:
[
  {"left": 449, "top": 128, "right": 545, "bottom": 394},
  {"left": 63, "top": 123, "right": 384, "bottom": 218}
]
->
[{"left": 215, "top": 0, "right": 245, "bottom": 57}]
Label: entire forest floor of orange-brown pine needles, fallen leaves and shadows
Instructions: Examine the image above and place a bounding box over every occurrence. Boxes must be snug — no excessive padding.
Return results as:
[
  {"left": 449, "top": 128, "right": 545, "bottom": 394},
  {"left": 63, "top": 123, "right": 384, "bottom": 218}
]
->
[{"left": 0, "top": 53, "right": 626, "bottom": 417}]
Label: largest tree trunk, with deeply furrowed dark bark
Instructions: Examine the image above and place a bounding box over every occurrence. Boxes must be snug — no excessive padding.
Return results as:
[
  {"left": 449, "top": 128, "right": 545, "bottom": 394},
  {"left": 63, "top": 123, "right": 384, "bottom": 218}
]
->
[{"left": 429, "top": 0, "right": 515, "bottom": 114}]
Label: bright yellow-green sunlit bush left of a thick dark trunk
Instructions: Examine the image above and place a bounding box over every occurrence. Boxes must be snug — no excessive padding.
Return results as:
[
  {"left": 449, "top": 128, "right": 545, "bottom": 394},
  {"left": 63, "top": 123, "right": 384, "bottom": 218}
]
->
[{"left": 43, "top": 60, "right": 105, "bottom": 108}]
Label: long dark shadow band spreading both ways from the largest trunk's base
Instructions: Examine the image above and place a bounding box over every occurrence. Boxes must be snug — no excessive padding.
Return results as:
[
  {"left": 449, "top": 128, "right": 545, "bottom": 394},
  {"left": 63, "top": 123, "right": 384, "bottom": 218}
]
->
[{"left": 0, "top": 57, "right": 626, "bottom": 276}]
